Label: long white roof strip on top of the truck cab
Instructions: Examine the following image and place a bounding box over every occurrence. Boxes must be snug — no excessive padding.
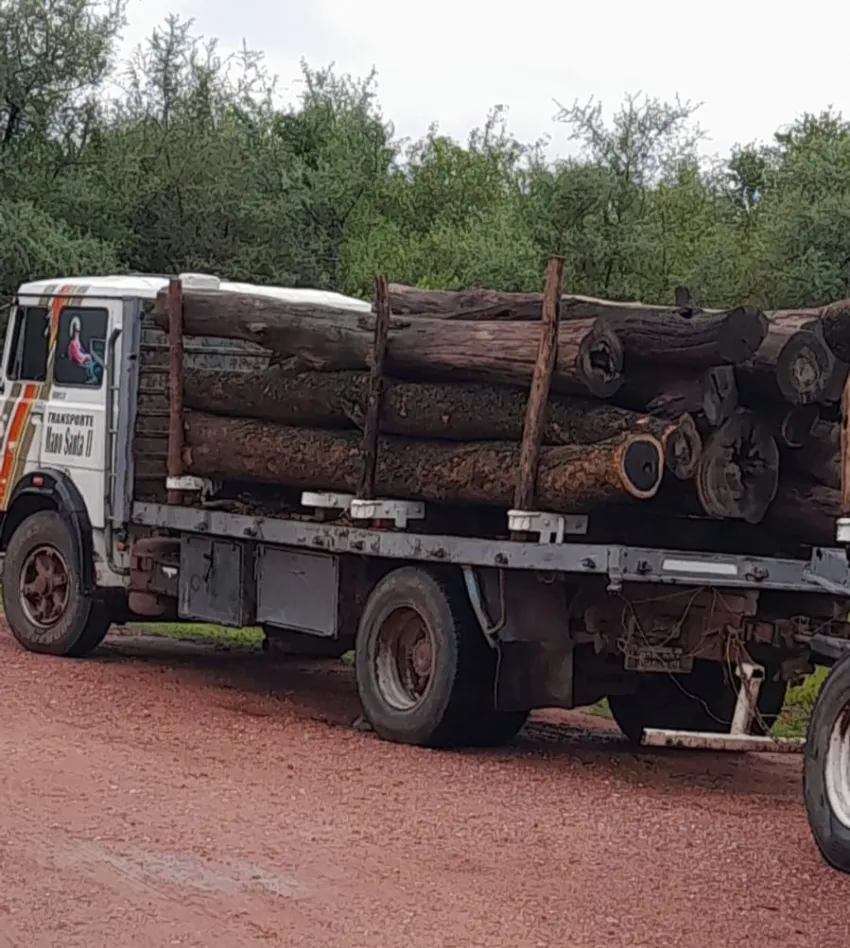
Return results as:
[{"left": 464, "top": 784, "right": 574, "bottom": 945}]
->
[{"left": 18, "top": 273, "right": 371, "bottom": 313}]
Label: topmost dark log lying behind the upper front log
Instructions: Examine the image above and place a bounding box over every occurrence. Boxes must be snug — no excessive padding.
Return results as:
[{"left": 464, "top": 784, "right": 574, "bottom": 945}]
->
[{"left": 390, "top": 283, "right": 767, "bottom": 368}]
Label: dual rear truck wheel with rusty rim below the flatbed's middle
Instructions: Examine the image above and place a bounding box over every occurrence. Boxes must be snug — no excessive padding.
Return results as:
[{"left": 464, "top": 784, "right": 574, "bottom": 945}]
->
[{"left": 355, "top": 567, "right": 525, "bottom": 747}]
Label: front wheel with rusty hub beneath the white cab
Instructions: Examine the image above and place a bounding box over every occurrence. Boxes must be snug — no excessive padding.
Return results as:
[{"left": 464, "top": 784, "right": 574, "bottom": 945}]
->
[{"left": 2, "top": 510, "right": 109, "bottom": 657}]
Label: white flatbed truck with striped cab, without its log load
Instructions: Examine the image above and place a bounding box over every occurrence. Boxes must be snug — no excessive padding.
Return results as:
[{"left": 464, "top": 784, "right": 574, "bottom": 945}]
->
[{"left": 0, "top": 274, "right": 850, "bottom": 871}]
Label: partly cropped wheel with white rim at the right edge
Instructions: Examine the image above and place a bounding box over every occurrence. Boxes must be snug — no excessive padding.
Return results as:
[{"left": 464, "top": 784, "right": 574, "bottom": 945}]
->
[{"left": 803, "top": 656, "right": 850, "bottom": 873}]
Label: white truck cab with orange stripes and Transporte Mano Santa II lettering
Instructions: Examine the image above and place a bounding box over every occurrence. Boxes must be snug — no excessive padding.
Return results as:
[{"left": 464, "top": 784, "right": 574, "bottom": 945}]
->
[{"left": 0, "top": 274, "right": 370, "bottom": 651}]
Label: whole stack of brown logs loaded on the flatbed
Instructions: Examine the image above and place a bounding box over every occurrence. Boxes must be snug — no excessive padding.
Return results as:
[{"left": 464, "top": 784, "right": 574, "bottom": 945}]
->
[{"left": 149, "top": 262, "right": 850, "bottom": 552}]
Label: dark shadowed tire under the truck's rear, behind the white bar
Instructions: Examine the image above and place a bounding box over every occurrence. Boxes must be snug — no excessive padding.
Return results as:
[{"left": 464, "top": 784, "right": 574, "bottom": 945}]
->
[{"left": 608, "top": 659, "right": 788, "bottom": 744}]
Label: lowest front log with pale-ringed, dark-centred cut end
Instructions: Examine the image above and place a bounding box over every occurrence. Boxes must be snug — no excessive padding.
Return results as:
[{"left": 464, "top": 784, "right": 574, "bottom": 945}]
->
[{"left": 184, "top": 412, "right": 664, "bottom": 513}]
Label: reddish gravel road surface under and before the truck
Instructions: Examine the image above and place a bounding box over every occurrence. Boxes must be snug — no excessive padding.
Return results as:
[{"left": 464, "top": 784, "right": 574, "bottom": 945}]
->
[{"left": 0, "top": 632, "right": 850, "bottom": 948}]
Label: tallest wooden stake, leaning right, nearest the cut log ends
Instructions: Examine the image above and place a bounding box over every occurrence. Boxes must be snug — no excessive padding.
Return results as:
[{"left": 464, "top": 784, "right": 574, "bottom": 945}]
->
[{"left": 514, "top": 256, "right": 564, "bottom": 510}]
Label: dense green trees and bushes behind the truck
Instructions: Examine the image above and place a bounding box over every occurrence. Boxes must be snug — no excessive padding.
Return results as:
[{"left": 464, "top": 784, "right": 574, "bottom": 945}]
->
[{"left": 0, "top": 0, "right": 850, "bottom": 307}]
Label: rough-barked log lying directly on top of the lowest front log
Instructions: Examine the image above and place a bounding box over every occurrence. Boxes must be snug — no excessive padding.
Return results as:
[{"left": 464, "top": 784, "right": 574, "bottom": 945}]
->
[{"left": 183, "top": 366, "right": 702, "bottom": 478}]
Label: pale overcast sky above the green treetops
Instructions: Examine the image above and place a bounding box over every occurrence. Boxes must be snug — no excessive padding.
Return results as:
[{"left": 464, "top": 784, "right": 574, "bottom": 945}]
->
[{"left": 119, "top": 0, "right": 850, "bottom": 161}]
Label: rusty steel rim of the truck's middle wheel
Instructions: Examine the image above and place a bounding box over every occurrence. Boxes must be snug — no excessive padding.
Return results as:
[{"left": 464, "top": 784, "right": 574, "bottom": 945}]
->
[{"left": 375, "top": 607, "right": 436, "bottom": 711}]
